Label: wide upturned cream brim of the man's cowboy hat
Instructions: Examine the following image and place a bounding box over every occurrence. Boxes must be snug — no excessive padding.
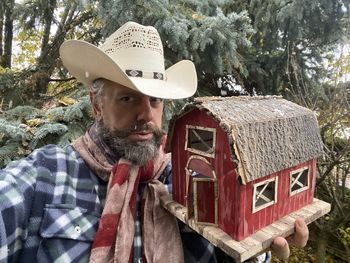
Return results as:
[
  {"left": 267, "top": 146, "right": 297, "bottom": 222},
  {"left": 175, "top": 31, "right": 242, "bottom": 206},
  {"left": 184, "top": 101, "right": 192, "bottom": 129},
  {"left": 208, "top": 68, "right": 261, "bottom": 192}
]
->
[{"left": 60, "top": 40, "right": 197, "bottom": 99}]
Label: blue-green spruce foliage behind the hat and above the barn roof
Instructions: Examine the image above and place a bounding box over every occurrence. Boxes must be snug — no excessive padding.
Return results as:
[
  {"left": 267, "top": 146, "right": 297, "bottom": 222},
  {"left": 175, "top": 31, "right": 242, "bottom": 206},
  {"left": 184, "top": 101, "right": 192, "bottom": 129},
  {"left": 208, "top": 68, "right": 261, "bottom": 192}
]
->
[{"left": 95, "top": 0, "right": 350, "bottom": 99}]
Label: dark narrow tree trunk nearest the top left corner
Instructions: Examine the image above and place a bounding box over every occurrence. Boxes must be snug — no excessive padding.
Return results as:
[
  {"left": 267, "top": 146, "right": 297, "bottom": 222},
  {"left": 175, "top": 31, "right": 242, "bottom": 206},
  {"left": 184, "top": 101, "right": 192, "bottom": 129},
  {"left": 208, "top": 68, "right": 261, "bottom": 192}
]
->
[{"left": 1, "top": 0, "right": 15, "bottom": 68}]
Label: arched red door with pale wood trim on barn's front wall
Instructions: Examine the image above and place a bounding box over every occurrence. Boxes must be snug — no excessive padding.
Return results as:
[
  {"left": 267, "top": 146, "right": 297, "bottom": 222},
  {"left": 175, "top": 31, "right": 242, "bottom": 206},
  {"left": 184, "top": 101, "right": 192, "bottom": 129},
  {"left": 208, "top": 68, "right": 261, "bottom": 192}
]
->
[{"left": 186, "top": 156, "right": 218, "bottom": 227}]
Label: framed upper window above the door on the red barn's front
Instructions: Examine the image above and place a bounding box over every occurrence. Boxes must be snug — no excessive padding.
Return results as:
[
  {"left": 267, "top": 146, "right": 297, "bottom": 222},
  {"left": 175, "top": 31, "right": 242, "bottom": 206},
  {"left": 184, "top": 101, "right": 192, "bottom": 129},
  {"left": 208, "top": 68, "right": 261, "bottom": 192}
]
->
[{"left": 186, "top": 125, "right": 216, "bottom": 157}]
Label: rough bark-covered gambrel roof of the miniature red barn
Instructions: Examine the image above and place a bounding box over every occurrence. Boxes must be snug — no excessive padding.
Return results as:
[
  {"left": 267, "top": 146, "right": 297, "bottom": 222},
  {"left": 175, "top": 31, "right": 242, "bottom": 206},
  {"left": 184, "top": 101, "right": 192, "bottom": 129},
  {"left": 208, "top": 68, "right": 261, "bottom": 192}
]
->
[{"left": 167, "top": 96, "right": 323, "bottom": 183}]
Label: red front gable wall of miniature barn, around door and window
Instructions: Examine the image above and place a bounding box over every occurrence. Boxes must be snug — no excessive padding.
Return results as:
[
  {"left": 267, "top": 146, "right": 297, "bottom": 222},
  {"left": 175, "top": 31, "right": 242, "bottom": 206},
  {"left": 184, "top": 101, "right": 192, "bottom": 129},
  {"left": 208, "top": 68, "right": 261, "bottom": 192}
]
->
[{"left": 171, "top": 109, "right": 239, "bottom": 233}]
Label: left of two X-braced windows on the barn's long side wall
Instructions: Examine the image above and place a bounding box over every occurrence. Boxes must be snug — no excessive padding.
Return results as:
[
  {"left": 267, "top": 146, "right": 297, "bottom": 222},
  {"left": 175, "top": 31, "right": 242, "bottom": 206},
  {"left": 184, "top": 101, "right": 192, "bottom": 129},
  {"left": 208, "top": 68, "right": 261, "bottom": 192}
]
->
[{"left": 253, "top": 177, "right": 278, "bottom": 213}]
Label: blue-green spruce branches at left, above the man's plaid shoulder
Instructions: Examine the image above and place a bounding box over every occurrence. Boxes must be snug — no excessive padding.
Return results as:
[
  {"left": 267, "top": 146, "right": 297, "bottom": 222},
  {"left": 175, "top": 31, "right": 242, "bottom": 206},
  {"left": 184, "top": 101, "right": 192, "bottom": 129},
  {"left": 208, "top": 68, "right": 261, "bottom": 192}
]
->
[{"left": 0, "top": 96, "right": 92, "bottom": 167}]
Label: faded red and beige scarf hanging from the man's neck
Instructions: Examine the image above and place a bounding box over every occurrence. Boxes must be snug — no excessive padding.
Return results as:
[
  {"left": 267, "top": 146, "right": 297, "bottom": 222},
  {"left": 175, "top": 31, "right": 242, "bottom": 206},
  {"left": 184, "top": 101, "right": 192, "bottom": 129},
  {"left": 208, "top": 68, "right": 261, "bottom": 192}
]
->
[{"left": 73, "top": 132, "right": 184, "bottom": 263}]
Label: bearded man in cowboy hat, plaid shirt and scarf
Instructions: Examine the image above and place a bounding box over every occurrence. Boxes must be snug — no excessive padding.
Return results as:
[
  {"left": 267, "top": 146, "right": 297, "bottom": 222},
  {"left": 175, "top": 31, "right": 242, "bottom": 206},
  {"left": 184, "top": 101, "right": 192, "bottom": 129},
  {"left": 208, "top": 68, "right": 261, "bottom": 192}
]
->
[{"left": 0, "top": 22, "right": 308, "bottom": 263}]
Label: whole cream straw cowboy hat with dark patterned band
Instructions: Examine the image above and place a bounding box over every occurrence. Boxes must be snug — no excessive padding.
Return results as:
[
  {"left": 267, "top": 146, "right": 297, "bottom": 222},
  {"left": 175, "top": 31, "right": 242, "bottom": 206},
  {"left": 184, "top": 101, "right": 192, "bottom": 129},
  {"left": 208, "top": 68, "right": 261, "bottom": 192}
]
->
[{"left": 60, "top": 22, "right": 197, "bottom": 99}]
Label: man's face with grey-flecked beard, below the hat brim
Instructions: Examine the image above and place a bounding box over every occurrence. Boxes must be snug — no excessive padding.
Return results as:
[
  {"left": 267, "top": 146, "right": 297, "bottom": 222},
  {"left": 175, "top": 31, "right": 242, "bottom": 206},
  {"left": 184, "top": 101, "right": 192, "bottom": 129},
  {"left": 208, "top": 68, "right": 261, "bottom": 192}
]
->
[{"left": 92, "top": 81, "right": 163, "bottom": 165}]
